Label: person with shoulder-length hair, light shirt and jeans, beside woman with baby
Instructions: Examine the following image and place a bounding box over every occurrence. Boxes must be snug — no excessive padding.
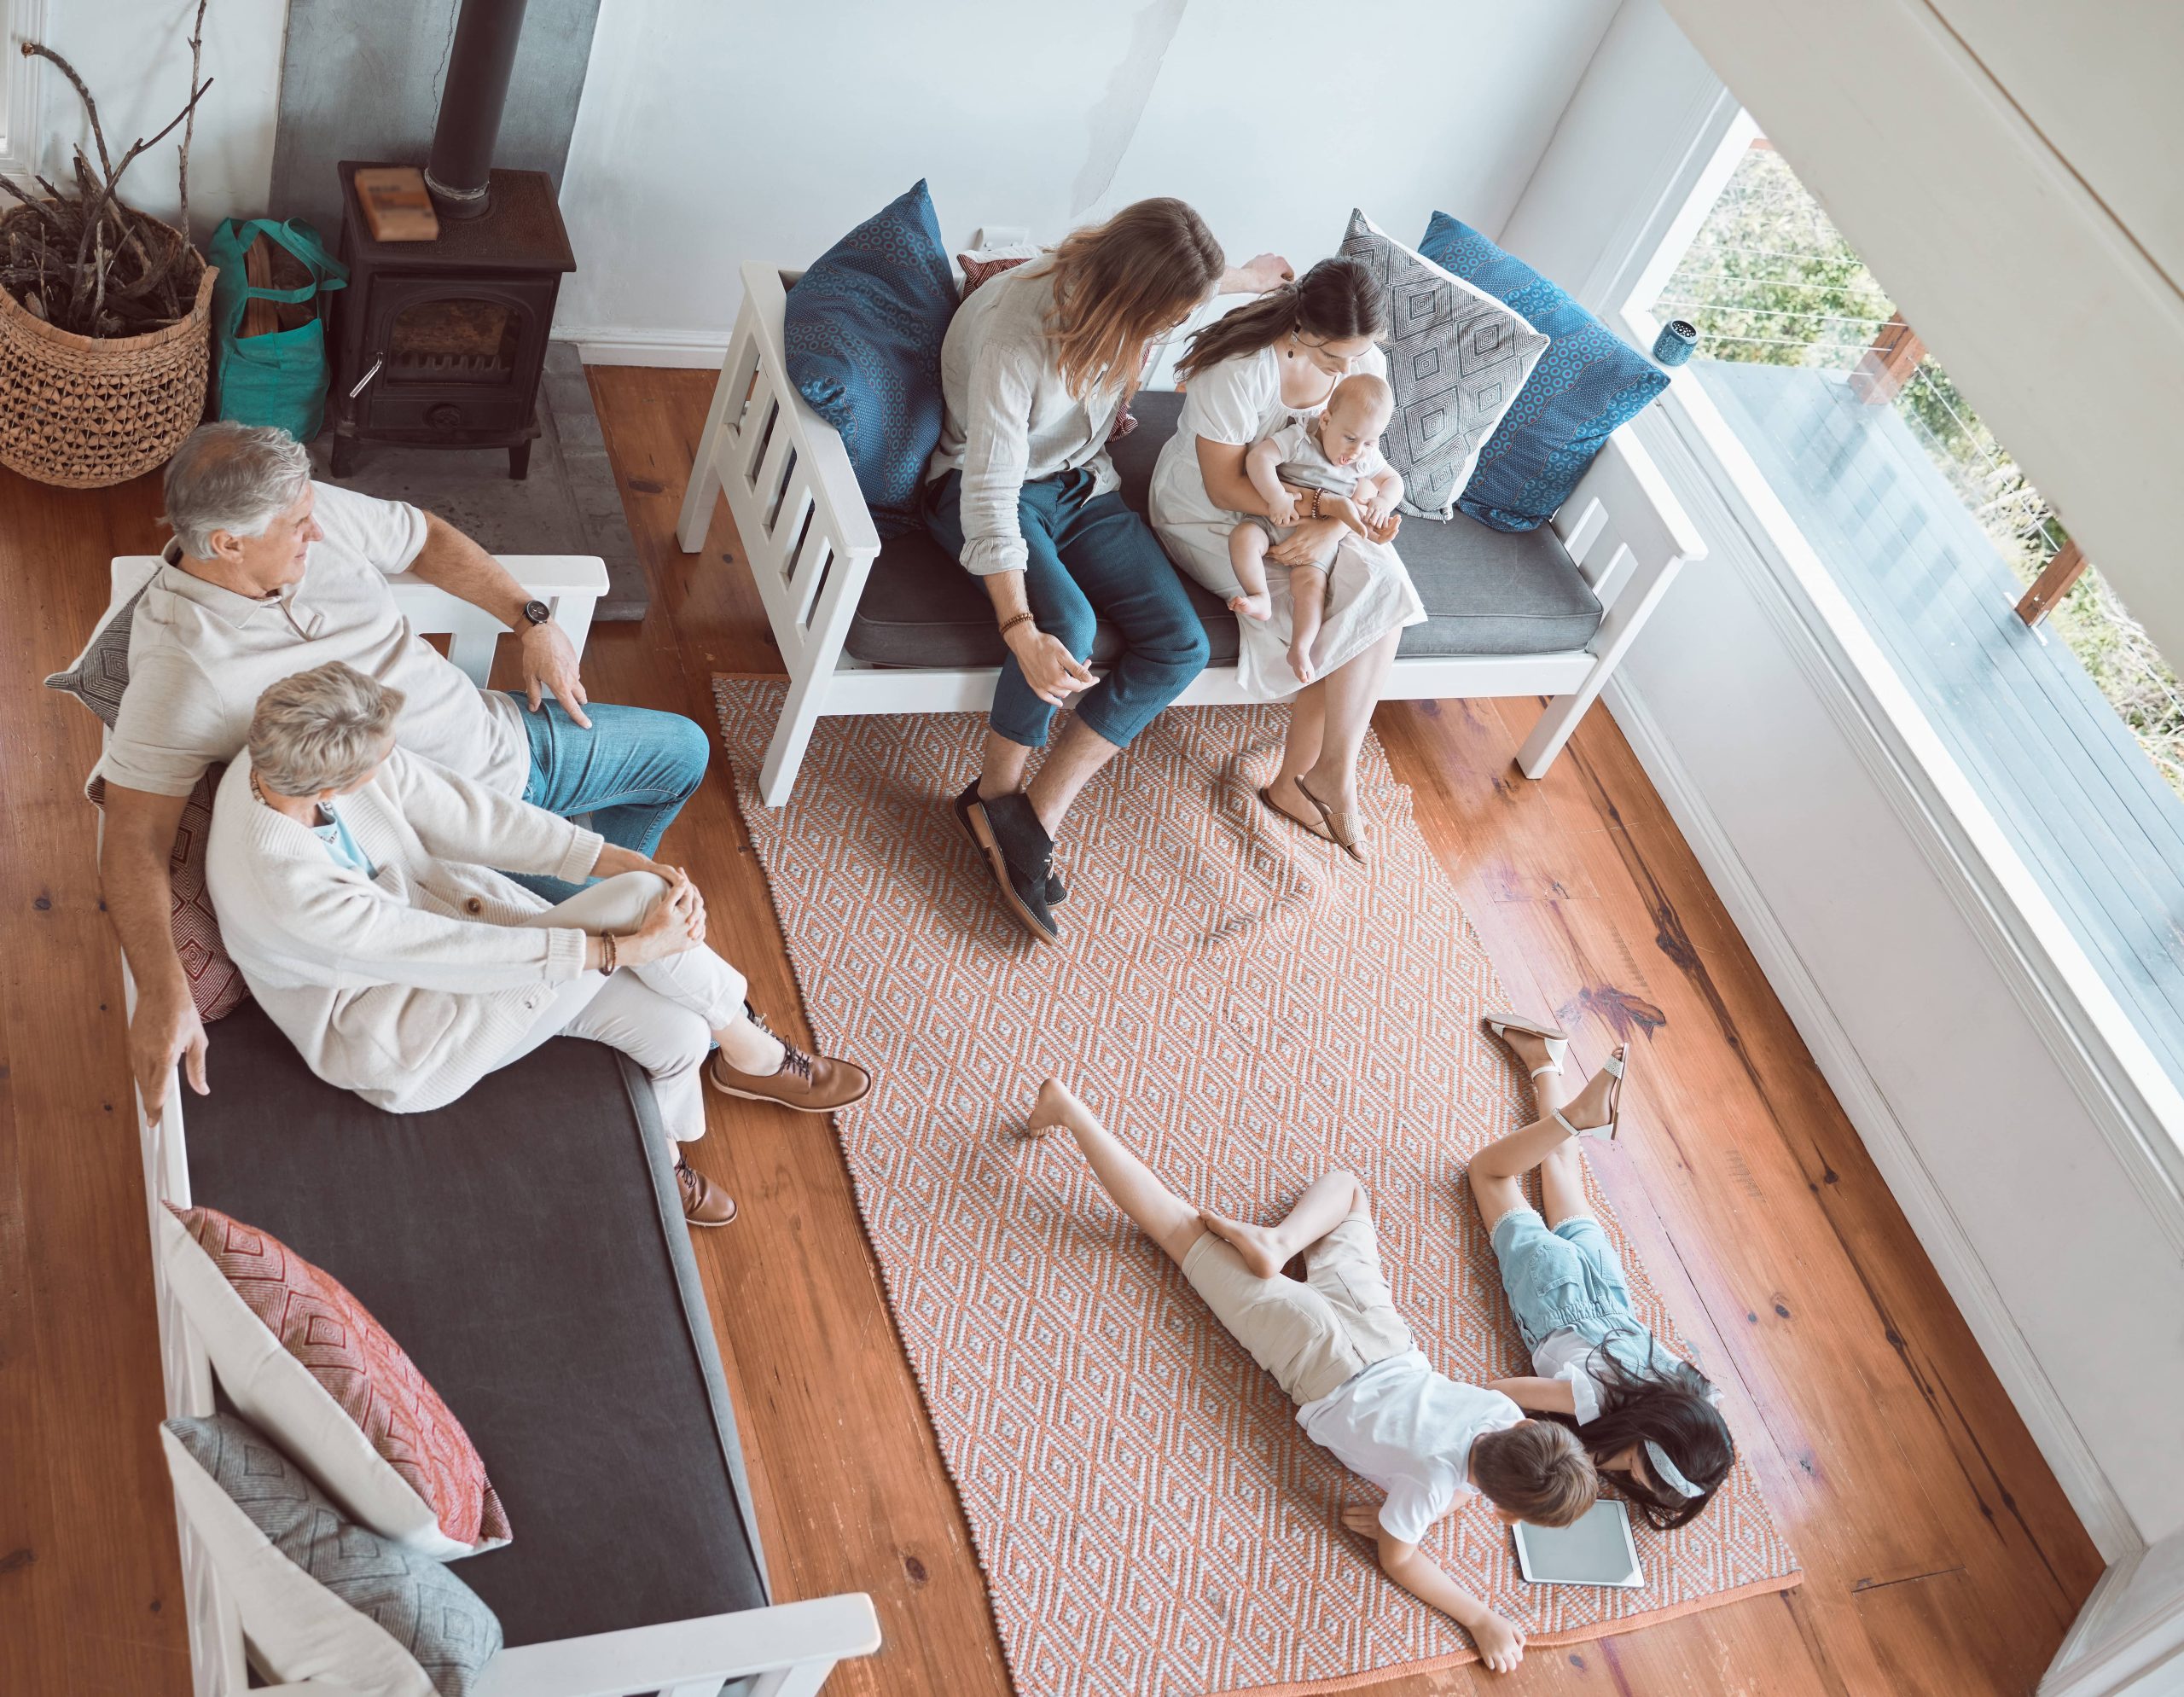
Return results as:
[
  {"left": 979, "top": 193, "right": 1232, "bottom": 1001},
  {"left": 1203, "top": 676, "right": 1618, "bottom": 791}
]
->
[{"left": 921, "top": 199, "right": 1288, "bottom": 944}]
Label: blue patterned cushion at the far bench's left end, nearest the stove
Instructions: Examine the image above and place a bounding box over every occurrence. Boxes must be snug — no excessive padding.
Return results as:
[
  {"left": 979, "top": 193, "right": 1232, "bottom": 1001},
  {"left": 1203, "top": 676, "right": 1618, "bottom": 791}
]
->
[{"left": 781, "top": 179, "right": 956, "bottom": 538}]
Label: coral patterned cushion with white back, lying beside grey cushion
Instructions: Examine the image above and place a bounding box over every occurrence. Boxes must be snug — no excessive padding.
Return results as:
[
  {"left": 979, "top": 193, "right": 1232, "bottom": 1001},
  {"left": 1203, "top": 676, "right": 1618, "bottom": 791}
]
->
[{"left": 161, "top": 1208, "right": 508, "bottom": 1561}]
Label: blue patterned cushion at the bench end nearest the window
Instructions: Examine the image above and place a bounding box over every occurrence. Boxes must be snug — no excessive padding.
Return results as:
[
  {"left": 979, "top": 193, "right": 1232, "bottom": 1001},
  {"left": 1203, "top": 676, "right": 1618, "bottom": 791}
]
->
[{"left": 1417, "top": 212, "right": 1669, "bottom": 531}]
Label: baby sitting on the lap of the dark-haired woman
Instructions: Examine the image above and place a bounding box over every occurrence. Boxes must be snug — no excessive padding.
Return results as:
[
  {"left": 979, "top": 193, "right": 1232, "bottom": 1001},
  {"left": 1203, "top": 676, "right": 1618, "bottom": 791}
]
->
[{"left": 1228, "top": 371, "right": 1403, "bottom": 683}]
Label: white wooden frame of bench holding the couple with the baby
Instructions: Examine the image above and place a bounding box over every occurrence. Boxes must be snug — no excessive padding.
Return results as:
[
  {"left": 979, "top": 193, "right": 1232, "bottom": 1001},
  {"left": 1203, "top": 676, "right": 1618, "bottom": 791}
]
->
[{"left": 677, "top": 264, "right": 1705, "bottom": 806}]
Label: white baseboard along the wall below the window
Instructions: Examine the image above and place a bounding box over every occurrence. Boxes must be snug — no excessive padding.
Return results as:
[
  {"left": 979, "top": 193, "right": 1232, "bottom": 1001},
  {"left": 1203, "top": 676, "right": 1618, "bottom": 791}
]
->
[{"left": 1600, "top": 672, "right": 2145, "bottom": 1561}]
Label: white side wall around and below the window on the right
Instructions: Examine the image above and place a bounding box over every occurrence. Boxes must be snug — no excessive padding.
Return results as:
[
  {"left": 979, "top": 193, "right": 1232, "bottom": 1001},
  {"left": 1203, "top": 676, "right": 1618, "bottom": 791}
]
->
[{"left": 1505, "top": 0, "right": 2184, "bottom": 1544}]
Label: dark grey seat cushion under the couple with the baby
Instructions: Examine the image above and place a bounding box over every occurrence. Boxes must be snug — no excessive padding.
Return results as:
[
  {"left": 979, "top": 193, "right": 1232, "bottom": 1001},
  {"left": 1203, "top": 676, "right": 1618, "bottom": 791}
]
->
[{"left": 845, "top": 391, "right": 1600, "bottom": 668}]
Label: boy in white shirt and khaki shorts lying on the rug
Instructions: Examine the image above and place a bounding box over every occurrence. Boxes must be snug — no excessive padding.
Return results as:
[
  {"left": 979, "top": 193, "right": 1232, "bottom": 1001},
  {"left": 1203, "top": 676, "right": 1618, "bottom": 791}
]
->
[{"left": 1025, "top": 1079, "right": 1599, "bottom": 1673}]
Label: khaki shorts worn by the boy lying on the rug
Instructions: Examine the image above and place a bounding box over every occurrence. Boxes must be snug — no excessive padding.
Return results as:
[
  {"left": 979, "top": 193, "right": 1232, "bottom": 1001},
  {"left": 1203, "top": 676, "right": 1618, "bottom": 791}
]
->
[{"left": 1184, "top": 1212, "right": 1413, "bottom": 1409}]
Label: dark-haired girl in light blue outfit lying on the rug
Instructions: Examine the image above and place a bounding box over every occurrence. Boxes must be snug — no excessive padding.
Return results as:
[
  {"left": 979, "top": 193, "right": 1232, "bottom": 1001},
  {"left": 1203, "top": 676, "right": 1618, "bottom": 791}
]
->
[{"left": 1470, "top": 1014, "right": 1736, "bottom": 1531}]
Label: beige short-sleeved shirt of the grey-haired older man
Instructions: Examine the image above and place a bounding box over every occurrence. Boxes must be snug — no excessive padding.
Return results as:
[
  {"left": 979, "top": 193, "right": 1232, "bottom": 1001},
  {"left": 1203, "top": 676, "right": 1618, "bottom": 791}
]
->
[{"left": 98, "top": 483, "right": 531, "bottom": 795}]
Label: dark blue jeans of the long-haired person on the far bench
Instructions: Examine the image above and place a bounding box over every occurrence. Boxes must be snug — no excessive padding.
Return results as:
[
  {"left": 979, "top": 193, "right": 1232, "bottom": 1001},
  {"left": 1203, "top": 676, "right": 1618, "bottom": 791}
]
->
[{"left": 924, "top": 469, "right": 1208, "bottom": 749}]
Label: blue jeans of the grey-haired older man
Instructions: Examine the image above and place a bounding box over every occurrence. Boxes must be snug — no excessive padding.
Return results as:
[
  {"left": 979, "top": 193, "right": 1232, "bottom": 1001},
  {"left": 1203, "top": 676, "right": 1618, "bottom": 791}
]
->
[{"left": 511, "top": 690, "right": 712, "bottom": 902}]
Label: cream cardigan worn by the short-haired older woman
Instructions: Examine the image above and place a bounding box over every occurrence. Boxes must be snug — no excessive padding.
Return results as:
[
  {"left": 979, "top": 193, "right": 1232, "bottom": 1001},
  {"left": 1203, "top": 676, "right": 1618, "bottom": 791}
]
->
[{"left": 206, "top": 749, "right": 603, "bottom": 1114}]
